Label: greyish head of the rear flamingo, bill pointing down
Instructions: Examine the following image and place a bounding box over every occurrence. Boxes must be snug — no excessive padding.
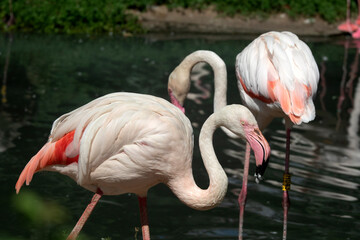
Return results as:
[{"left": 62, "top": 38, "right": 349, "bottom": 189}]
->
[{"left": 168, "top": 66, "right": 190, "bottom": 113}]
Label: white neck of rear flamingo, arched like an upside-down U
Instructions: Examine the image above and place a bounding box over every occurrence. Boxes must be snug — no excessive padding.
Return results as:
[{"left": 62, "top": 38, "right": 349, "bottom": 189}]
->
[{"left": 181, "top": 50, "right": 227, "bottom": 112}]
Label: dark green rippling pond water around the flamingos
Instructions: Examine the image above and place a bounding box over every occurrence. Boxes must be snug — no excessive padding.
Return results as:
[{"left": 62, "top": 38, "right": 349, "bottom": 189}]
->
[{"left": 0, "top": 35, "right": 360, "bottom": 239}]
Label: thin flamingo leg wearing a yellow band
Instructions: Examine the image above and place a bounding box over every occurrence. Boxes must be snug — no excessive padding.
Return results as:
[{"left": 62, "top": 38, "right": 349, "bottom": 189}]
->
[{"left": 282, "top": 128, "right": 291, "bottom": 240}]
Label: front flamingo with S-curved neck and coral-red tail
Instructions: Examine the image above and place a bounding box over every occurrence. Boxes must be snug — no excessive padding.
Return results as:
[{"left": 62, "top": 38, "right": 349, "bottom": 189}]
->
[{"left": 15, "top": 92, "right": 269, "bottom": 240}]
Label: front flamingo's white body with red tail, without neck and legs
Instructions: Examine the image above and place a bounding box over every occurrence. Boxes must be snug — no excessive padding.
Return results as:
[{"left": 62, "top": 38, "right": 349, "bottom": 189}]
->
[{"left": 16, "top": 93, "right": 193, "bottom": 196}]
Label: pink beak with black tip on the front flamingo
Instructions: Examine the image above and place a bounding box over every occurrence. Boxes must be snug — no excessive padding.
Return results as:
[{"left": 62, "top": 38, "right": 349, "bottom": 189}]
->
[{"left": 246, "top": 127, "right": 270, "bottom": 183}]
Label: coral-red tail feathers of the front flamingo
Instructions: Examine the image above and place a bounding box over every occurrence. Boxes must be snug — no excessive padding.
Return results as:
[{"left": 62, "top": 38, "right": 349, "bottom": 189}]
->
[{"left": 15, "top": 131, "right": 78, "bottom": 193}]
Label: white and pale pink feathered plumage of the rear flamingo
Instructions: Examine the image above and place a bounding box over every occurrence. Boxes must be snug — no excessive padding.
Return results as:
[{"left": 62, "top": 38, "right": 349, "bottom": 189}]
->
[{"left": 236, "top": 32, "right": 319, "bottom": 124}]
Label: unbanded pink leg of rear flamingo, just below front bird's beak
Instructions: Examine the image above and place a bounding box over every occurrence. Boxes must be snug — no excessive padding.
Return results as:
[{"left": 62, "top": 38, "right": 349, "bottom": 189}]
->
[{"left": 238, "top": 143, "right": 250, "bottom": 240}]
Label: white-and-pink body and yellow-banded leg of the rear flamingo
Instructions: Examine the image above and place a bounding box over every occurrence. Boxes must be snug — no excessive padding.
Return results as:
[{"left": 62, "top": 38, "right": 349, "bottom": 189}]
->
[{"left": 235, "top": 32, "right": 319, "bottom": 238}]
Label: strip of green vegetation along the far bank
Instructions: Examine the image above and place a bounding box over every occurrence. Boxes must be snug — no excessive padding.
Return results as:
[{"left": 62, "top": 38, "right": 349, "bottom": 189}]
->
[{"left": 0, "top": 0, "right": 357, "bottom": 34}]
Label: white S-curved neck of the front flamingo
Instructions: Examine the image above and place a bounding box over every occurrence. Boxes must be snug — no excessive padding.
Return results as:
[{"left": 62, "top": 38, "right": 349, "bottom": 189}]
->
[{"left": 168, "top": 115, "right": 228, "bottom": 210}]
